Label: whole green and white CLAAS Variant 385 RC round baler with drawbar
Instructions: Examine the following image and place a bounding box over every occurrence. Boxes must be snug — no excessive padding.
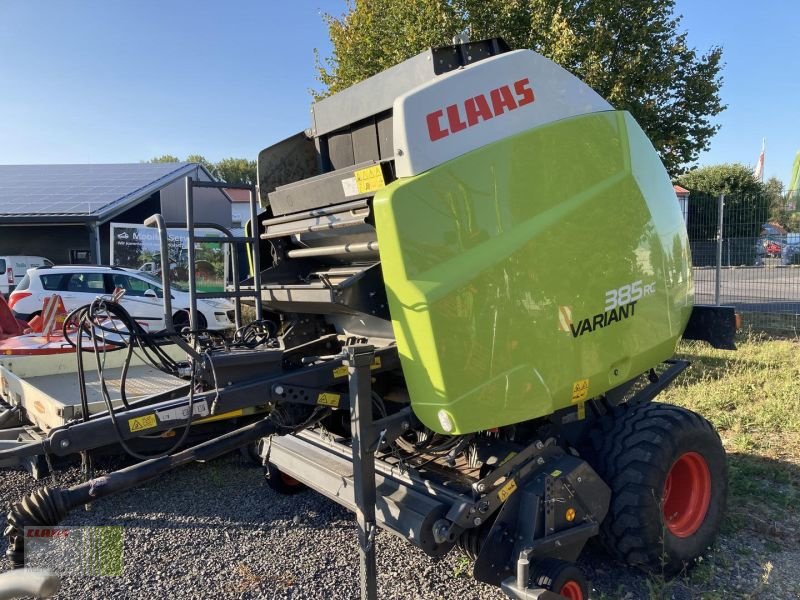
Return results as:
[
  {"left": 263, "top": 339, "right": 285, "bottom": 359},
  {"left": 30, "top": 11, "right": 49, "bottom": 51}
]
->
[{"left": 7, "top": 39, "right": 733, "bottom": 600}]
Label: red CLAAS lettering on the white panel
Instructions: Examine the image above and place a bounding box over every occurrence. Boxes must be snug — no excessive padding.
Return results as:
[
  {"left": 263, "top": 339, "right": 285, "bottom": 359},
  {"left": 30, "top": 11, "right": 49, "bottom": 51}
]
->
[{"left": 426, "top": 77, "right": 536, "bottom": 142}]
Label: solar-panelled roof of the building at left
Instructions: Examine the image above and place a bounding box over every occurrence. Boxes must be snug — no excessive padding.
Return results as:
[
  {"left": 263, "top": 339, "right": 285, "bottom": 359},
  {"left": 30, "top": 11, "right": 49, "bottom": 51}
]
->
[{"left": 0, "top": 163, "right": 210, "bottom": 222}]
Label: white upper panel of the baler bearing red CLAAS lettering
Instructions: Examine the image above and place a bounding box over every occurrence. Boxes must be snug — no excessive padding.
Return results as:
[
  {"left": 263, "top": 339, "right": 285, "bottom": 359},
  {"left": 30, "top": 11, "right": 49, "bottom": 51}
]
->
[{"left": 394, "top": 50, "right": 613, "bottom": 177}]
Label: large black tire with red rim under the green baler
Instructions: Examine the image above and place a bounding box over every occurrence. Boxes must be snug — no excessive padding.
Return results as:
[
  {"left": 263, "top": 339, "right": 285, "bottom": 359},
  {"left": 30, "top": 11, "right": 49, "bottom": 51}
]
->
[{"left": 587, "top": 402, "right": 728, "bottom": 575}]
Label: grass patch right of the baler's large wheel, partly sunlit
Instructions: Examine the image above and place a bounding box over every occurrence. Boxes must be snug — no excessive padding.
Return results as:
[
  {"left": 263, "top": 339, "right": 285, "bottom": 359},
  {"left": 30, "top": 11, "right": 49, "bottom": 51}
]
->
[{"left": 660, "top": 334, "right": 800, "bottom": 543}]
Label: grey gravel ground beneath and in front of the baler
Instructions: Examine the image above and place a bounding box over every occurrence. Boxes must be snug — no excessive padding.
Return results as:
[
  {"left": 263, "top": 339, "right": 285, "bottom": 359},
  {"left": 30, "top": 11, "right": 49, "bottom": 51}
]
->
[{"left": 0, "top": 455, "right": 800, "bottom": 600}]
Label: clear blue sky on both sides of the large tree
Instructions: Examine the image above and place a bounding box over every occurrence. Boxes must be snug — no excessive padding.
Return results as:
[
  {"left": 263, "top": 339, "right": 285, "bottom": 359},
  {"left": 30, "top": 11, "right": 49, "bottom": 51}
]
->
[{"left": 0, "top": 0, "right": 800, "bottom": 183}]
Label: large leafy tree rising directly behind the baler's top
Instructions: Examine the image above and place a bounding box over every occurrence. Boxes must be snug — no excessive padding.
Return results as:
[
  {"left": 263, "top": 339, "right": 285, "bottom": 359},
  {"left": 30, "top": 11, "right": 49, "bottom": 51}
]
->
[{"left": 316, "top": 0, "right": 725, "bottom": 175}]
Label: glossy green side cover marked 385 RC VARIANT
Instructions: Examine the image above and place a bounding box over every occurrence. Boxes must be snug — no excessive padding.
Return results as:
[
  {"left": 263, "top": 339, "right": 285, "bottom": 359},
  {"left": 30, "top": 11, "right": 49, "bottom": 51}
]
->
[{"left": 374, "top": 111, "right": 694, "bottom": 434}]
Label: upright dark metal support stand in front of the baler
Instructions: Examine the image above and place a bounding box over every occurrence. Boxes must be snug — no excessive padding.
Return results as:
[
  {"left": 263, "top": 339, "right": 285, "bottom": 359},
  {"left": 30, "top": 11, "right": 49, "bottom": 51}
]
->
[{"left": 346, "top": 345, "right": 378, "bottom": 600}]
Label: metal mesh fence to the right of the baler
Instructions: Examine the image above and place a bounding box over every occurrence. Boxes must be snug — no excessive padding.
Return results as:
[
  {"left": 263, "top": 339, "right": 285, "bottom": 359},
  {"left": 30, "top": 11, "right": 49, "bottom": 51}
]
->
[{"left": 684, "top": 192, "right": 800, "bottom": 334}]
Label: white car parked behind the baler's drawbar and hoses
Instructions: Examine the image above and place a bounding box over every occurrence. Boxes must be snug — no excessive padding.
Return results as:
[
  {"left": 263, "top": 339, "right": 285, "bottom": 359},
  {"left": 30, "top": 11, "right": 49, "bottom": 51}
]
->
[{"left": 8, "top": 265, "right": 235, "bottom": 331}]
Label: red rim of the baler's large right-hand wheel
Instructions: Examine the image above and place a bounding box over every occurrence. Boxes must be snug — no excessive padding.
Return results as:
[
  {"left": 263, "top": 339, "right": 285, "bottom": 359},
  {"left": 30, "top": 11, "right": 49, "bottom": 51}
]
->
[{"left": 663, "top": 452, "right": 711, "bottom": 538}]
